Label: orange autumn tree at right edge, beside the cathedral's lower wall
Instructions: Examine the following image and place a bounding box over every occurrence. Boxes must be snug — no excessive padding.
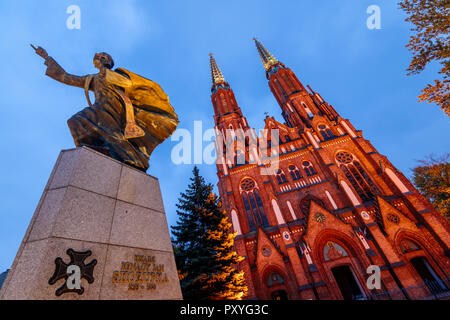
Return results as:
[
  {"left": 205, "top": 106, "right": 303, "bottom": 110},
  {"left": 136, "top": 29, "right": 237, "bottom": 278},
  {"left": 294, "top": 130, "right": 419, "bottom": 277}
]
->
[{"left": 413, "top": 154, "right": 450, "bottom": 222}]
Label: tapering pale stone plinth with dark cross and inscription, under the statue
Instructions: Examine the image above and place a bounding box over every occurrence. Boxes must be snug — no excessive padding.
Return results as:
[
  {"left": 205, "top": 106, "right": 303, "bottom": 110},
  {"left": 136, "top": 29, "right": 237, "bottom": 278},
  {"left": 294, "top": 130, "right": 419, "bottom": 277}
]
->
[{"left": 0, "top": 147, "right": 182, "bottom": 300}]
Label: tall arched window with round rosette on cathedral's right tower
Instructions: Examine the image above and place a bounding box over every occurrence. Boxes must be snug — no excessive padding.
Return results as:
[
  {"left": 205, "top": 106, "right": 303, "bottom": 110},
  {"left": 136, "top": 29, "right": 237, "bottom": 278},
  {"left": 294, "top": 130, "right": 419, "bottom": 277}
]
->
[{"left": 336, "top": 151, "right": 379, "bottom": 201}]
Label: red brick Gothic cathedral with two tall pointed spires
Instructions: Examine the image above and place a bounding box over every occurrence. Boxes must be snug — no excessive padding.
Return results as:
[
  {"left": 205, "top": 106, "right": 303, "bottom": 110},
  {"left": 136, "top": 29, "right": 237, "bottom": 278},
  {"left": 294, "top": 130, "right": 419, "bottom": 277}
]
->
[{"left": 210, "top": 39, "right": 450, "bottom": 300}]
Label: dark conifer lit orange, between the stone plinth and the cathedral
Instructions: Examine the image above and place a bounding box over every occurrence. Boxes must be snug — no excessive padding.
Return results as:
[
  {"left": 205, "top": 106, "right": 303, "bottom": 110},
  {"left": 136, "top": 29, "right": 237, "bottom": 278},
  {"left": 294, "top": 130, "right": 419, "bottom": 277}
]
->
[{"left": 171, "top": 167, "right": 247, "bottom": 300}]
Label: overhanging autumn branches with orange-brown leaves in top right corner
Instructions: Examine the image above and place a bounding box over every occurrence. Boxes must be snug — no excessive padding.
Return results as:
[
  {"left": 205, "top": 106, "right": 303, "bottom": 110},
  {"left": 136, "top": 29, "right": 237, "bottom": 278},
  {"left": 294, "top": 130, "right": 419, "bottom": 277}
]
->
[{"left": 399, "top": 0, "right": 450, "bottom": 116}]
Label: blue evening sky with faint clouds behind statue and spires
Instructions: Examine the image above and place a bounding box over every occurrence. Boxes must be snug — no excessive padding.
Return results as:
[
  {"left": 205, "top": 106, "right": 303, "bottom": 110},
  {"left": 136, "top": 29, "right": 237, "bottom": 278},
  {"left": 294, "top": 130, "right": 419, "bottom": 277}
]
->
[{"left": 0, "top": 0, "right": 450, "bottom": 272}]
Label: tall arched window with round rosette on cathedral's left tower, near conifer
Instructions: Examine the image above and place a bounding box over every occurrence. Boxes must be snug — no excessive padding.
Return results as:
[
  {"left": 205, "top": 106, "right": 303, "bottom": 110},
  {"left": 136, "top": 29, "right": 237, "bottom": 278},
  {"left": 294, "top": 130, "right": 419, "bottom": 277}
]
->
[{"left": 240, "top": 178, "right": 269, "bottom": 231}]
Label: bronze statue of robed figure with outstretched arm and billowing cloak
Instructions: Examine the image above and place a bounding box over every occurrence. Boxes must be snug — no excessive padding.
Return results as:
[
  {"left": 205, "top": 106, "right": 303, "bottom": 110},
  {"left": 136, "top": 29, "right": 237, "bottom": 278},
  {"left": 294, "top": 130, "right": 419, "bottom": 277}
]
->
[{"left": 31, "top": 45, "right": 178, "bottom": 171}]
